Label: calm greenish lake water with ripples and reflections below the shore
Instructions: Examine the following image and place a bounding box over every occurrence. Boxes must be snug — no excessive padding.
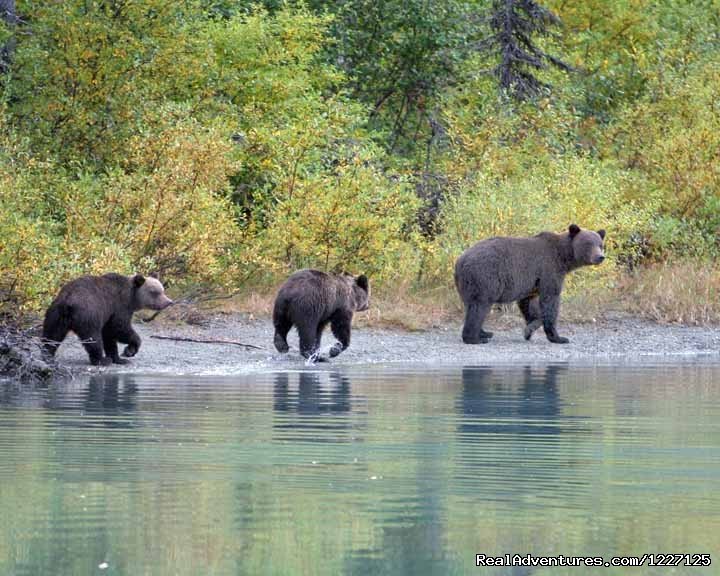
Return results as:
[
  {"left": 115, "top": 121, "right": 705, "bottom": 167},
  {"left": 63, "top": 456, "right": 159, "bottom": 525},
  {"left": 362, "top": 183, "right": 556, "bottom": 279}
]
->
[{"left": 0, "top": 361, "right": 720, "bottom": 576}]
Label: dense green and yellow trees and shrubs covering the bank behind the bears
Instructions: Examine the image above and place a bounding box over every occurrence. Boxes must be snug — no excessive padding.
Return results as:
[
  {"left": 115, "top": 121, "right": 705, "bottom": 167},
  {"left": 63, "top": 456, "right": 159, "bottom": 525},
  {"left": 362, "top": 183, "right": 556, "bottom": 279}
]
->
[{"left": 0, "top": 0, "right": 720, "bottom": 318}]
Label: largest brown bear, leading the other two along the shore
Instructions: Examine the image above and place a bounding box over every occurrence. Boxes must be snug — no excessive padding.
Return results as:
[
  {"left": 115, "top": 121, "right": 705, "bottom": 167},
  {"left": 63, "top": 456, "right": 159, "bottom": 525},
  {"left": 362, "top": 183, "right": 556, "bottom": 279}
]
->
[{"left": 455, "top": 224, "right": 605, "bottom": 344}]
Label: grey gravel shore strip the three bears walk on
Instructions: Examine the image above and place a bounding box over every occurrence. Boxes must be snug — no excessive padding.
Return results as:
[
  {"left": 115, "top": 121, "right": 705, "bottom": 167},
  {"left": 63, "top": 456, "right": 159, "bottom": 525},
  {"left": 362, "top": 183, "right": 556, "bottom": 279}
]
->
[{"left": 52, "top": 314, "right": 720, "bottom": 374}]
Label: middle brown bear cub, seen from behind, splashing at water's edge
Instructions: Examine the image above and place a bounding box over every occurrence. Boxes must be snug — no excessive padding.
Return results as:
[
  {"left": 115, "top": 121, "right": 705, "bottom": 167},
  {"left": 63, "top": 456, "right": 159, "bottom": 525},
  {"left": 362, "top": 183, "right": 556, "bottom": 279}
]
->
[{"left": 273, "top": 270, "right": 370, "bottom": 362}]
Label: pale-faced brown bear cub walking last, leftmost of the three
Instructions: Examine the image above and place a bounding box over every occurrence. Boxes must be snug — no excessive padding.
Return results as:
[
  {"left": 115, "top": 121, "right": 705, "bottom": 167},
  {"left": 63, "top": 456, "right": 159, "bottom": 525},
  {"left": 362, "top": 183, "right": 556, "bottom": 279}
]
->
[{"left": 43, "top": 273, "right": 173, "bottom": 365}]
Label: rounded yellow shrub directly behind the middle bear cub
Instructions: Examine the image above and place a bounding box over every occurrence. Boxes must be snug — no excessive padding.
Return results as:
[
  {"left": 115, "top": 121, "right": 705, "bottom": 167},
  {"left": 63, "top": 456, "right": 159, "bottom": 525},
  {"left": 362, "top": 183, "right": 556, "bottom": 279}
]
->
[{"left": 253, "top": 148, "right": 418, "bottom": 282}]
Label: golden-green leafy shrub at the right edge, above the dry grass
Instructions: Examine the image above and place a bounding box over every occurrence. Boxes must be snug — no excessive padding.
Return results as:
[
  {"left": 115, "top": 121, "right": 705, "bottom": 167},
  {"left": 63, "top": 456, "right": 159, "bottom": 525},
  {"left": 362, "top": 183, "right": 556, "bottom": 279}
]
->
[{"left": 609, "top": 59, "right": 720, "bottom": 254}]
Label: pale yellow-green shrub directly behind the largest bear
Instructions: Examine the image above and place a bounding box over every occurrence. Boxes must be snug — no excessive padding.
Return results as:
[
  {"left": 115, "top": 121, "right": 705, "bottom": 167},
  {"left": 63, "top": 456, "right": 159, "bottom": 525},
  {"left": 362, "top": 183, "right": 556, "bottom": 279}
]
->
[{"left": 427, "top": 155, "right": 650, "bottom": 292}]
